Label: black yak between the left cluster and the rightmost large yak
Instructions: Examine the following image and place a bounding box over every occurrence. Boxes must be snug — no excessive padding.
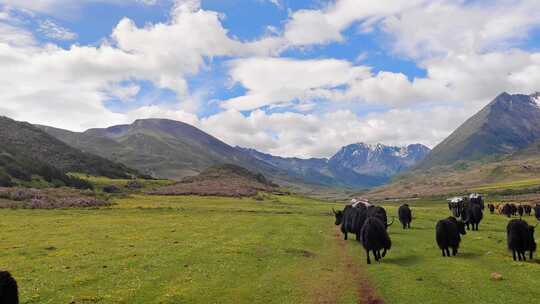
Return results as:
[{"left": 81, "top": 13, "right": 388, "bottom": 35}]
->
[{"left": 435, "top": 216, "right": 466, "bottom": 256}]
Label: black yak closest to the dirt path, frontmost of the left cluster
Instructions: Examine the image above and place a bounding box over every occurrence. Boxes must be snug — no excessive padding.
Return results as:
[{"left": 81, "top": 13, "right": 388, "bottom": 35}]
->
[{"left": 360, "top": 216, "right": 392, "bottom": 264}]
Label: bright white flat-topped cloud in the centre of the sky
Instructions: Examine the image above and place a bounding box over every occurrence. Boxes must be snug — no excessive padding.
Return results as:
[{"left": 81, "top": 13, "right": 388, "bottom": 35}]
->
[{"left": 222, "top": 57, "right": 369, "bottom": 110}]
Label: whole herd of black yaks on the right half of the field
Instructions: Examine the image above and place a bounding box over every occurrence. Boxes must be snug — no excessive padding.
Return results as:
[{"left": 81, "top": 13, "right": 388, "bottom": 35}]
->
[{"left": 332, "top": 194, "right": 540, "bottom": 264}]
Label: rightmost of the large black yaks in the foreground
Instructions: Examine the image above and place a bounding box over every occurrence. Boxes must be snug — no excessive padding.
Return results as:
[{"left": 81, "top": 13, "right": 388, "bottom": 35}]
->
[{"left": 506, "top": 219, "right": 536, "bottom": 261}]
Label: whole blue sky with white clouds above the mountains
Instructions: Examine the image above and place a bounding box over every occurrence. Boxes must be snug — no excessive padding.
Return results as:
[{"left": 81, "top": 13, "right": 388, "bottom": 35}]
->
[{"left": 0, "top": 0, "right": 540, "bottom": 157}]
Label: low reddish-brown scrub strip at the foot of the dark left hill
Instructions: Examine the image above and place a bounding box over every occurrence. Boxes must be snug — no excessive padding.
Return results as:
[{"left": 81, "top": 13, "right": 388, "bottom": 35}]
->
[{"left": 0, "top": 188, "right": 111, "bottom": 209}]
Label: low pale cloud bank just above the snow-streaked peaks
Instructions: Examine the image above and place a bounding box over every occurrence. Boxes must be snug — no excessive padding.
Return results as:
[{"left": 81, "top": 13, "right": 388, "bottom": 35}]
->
[{"left": 199, "top": 107, "right": 470, "bottom": 157}]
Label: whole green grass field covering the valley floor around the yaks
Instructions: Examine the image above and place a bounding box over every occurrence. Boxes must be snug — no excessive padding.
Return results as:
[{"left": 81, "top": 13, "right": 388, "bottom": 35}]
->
[{"left": 0, "top": 195, "right": 540, "bottom": 304}]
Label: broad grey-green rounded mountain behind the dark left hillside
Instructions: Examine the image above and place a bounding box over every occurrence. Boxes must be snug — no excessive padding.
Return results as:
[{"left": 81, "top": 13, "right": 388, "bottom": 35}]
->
[{"left": 39, "top": 119, "right": 288, "bottom": 180}]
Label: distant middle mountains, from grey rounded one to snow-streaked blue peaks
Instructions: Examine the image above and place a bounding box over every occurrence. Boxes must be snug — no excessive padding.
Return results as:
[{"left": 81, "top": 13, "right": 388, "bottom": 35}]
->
[{"left": 34, "top": 119, "right": 429, "bottom": 188}]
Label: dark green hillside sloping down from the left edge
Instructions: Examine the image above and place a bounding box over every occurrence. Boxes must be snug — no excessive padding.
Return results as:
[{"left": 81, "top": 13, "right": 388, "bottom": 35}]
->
[{"left": 0, "top": 116, "right": 140, "bottom": 186}]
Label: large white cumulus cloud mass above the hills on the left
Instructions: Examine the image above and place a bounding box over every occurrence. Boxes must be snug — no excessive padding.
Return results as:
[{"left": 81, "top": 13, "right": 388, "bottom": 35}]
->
[{"left": 0, "top": 1, "right": 278, "bottom": 130}]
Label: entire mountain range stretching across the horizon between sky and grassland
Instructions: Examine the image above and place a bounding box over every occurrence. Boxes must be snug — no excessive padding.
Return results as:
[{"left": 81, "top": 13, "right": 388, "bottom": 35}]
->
[{"left": 5, "top": 93, "right": 540, "bottom": 196}]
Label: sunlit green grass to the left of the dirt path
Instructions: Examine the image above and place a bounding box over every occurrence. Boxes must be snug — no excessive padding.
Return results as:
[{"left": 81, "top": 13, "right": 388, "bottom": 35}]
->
[{"left": 0, "top": 196, "right": 362, "bottom": 303}]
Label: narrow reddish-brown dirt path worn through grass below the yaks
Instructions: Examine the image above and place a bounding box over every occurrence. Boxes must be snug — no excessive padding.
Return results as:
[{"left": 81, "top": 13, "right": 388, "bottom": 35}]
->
[{"left": 335, "top": 231, "right": 384, "bottom": 304}]
